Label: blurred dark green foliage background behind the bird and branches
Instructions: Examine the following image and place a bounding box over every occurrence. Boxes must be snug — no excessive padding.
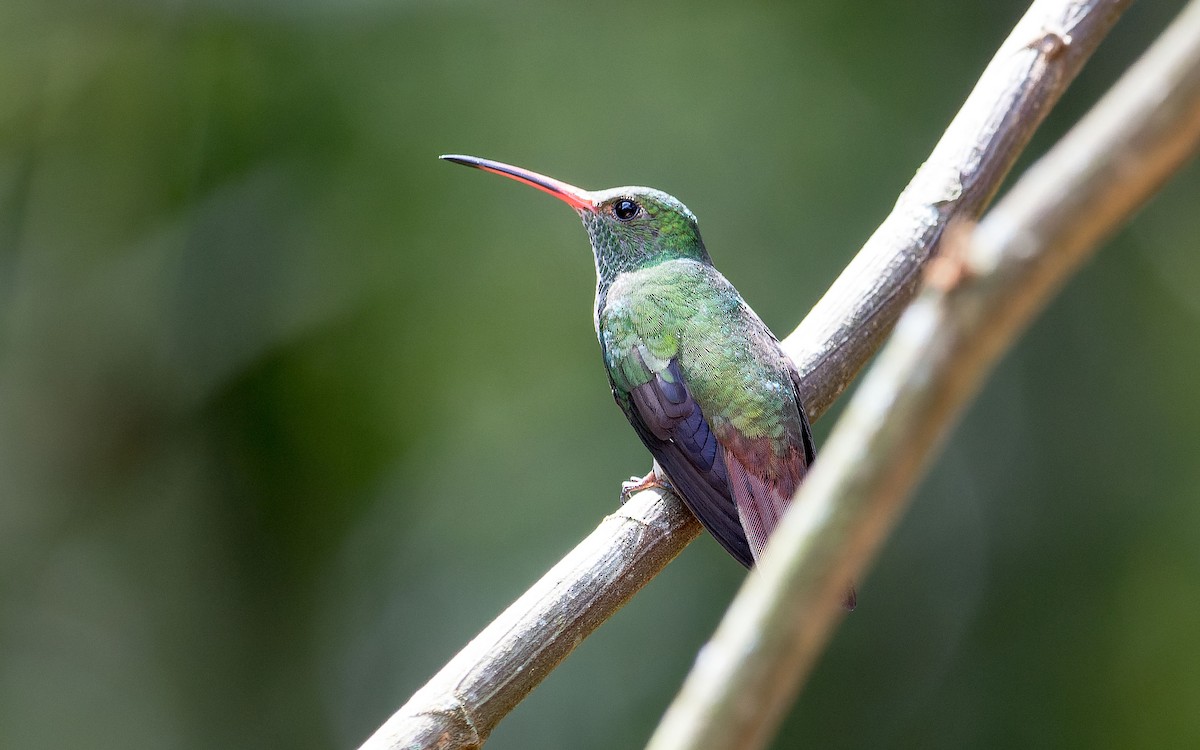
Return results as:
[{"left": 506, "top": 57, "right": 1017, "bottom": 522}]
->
[{"left": 0, "top": 0, "right": 1200, "bottom": 750}]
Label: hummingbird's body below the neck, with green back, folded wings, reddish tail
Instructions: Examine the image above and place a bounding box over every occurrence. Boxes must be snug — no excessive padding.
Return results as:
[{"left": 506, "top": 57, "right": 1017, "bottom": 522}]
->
[{"left": 596, "top": 263, "right": 814, "bottom": 566}]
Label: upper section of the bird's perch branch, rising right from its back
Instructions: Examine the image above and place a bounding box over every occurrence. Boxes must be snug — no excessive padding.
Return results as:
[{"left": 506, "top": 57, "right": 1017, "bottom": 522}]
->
[{"left": 784, "top": 0, "right": 1132, "bottom": 418}]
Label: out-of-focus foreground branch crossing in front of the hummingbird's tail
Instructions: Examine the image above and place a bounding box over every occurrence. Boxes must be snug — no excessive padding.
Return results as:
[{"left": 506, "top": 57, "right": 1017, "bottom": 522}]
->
[{"left": 649, "top": 0, "right": 1200, "bottom": 750}]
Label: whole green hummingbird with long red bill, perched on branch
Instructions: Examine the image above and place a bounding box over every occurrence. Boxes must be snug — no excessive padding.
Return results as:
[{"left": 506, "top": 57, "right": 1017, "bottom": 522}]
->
[{"left": 442, "top": 155, "right": 835, "bottom": 585}]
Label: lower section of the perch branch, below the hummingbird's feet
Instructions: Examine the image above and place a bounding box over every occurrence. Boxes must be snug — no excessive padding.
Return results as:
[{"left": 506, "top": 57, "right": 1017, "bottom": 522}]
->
[{"left": 362, "top": 490, "right": 700, "bottom": 750}]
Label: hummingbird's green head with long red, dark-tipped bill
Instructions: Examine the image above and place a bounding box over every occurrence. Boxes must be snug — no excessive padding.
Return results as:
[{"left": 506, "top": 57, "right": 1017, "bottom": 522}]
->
[{"left": 442, "top": 155, "right": 709, "bottom": 286}]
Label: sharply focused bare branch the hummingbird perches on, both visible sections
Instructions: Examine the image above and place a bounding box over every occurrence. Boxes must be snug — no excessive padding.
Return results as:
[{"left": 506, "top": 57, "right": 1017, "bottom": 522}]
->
[{"left": 362, "top": 0, "right": 1132, "bottom": 750}]
